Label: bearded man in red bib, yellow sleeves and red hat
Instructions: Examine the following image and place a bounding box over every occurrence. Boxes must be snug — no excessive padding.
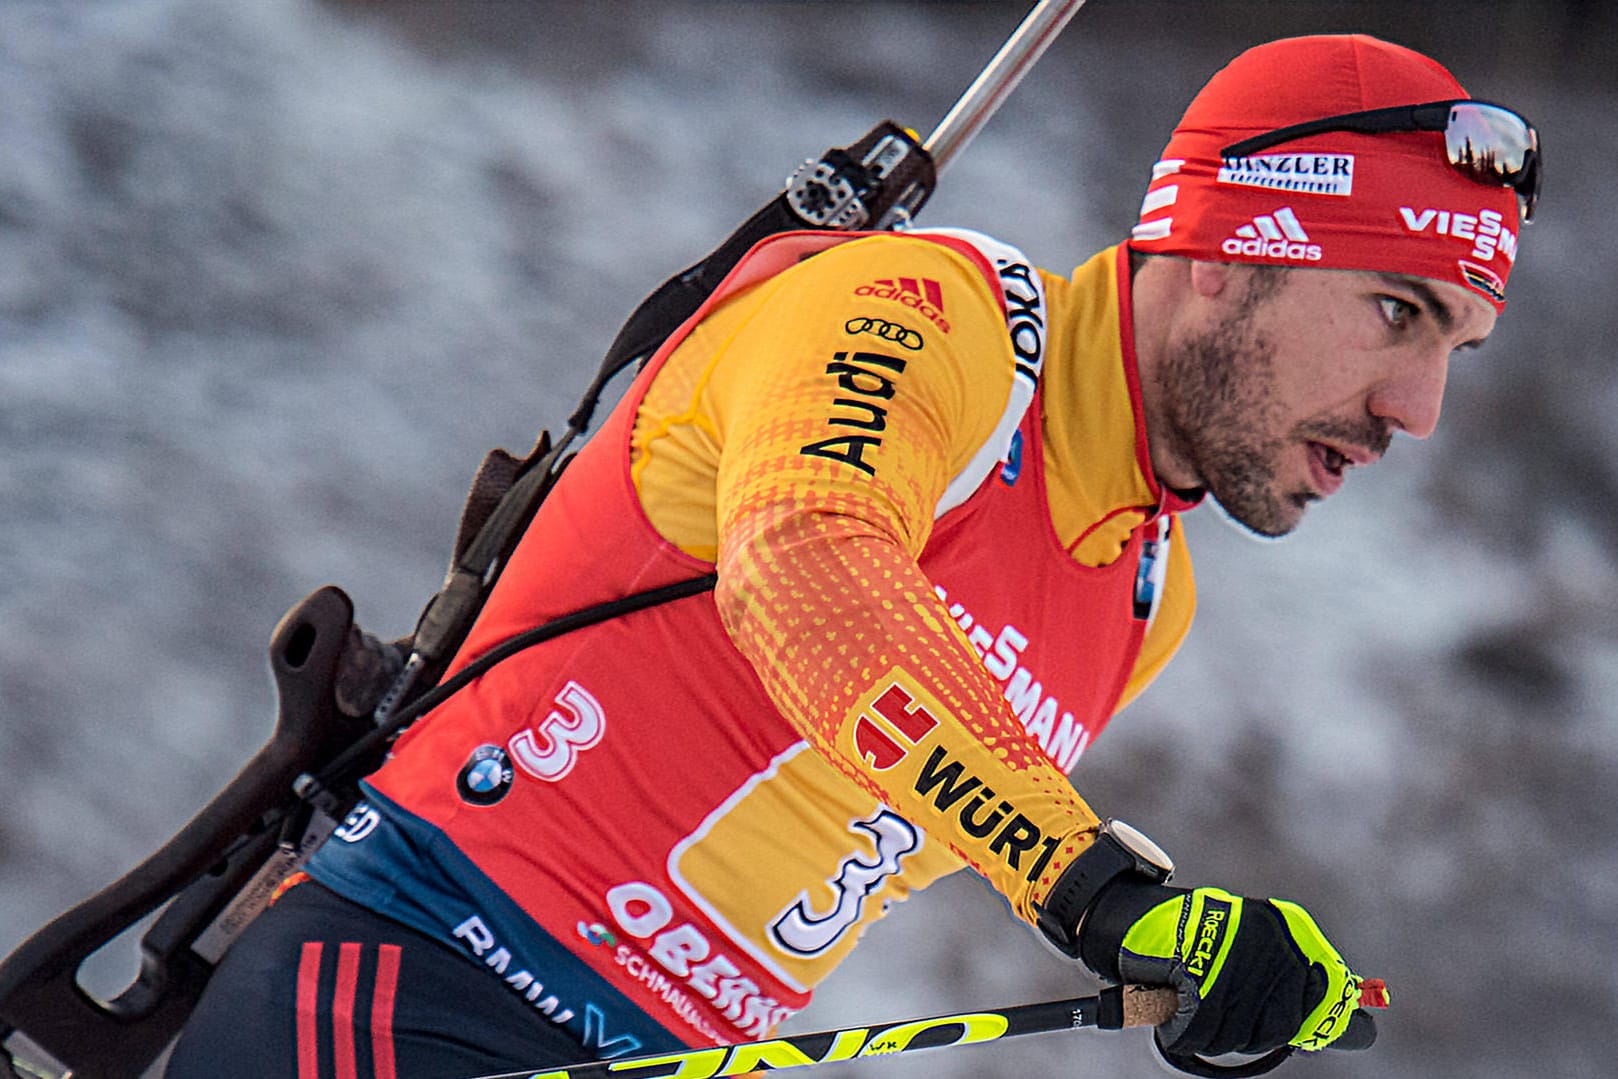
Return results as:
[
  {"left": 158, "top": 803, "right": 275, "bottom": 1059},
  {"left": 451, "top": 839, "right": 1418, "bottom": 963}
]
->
[{"left": 168, "top": 36, "right": 1539, "bottom": 1079}]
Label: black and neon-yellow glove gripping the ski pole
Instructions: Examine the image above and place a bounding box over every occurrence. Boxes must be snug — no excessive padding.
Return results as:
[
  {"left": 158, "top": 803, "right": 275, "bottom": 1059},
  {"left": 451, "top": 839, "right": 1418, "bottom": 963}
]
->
[{"left": 1078, "top": 880, "right": 1375, "bottom": 1056}]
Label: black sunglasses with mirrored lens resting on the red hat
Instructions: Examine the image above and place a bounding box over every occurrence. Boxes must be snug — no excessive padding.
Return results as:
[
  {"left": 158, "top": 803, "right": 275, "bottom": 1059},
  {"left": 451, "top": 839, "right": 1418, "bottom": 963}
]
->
[{"left": 1220, "top": 100, "right": 1540, "bottom": 222}]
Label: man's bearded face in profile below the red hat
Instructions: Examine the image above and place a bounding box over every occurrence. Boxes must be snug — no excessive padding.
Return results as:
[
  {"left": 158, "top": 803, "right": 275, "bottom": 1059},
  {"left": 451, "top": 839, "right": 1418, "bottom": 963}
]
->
[{"left": 1154, "top": 264, "right": 1495, "bottom": 535}]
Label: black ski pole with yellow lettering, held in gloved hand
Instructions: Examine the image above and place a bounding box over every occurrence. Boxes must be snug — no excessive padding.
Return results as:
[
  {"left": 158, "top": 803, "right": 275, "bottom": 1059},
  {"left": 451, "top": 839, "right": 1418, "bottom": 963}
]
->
[{"left": 477, "top": 985, "right": 1178, "bottom": 1079}]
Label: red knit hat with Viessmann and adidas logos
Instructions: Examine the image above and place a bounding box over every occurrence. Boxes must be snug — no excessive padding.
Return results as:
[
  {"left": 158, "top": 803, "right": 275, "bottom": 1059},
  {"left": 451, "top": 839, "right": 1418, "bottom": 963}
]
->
[{"left": 1133, "top": 34, "right": 1518, "bottom": 311}]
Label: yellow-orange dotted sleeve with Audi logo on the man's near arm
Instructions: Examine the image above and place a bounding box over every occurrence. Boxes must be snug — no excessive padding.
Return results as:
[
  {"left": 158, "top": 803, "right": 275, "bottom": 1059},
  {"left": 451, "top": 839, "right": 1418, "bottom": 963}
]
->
[{"left": 705, "top": 238, "right": 1097, "bottom": 922}]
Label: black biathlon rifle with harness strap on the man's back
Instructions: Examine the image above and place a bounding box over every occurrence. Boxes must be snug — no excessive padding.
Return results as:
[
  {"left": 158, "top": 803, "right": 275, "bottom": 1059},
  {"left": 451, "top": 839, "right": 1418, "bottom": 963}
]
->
[{"left": 0, "top": 0, "right": 1084, "bottom": 1079}]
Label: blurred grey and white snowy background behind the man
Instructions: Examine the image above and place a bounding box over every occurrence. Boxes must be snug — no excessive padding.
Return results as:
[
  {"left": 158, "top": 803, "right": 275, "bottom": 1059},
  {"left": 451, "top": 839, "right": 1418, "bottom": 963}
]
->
[{"left": 0, "top": 0, "right": 1618, "bottom": 1079}]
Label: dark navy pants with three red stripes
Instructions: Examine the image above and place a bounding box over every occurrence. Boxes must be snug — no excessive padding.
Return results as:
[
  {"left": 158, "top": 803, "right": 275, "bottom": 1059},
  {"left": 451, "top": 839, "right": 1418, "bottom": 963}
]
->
[{"left": 165, "top": 882, "right": 591, "bottom": 1079}]
